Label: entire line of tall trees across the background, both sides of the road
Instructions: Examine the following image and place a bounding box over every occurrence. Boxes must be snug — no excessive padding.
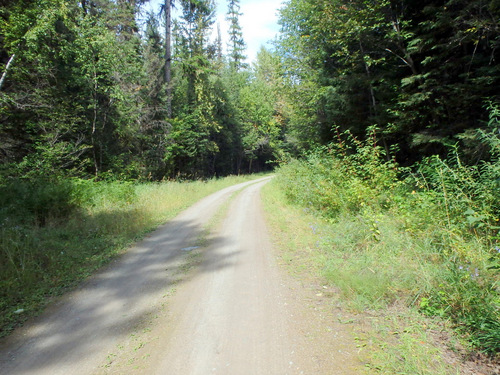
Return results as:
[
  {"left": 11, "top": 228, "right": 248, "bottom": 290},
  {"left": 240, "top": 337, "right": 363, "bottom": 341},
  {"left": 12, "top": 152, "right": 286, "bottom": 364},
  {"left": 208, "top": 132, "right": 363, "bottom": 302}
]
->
[{"left": 0, "top": 0, "right": 500, "bottom": 180}]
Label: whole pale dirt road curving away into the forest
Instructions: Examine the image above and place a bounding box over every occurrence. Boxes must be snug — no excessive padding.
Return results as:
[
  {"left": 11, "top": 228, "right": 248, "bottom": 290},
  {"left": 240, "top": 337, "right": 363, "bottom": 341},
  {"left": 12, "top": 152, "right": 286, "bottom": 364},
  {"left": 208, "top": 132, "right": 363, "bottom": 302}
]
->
[{"left": 0, "top": 178, "right": 356, "bottom": 375}]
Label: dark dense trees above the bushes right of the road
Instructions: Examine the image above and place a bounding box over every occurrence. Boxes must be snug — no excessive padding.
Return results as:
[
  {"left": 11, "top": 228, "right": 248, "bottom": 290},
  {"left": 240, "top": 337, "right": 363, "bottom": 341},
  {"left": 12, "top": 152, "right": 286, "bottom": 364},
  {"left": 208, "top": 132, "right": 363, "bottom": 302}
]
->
[{"left": 278, "top": 0, "right": 500, "bottom": 164}]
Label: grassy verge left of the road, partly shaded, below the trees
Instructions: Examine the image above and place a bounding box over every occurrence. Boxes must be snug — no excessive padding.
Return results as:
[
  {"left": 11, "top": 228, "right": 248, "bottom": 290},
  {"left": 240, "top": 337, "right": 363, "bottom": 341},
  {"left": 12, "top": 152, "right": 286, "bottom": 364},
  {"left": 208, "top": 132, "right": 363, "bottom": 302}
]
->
[{"left": 0, "top": 175, "right": 266, "bottom": 337}]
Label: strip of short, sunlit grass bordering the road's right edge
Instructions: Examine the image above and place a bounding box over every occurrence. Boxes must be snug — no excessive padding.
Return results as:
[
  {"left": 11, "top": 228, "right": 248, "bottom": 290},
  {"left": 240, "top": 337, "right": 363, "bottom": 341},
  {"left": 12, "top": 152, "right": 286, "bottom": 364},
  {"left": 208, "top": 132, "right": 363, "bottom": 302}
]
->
[{"left": 262, "top": 180, "right": 460, "bottom": 375}]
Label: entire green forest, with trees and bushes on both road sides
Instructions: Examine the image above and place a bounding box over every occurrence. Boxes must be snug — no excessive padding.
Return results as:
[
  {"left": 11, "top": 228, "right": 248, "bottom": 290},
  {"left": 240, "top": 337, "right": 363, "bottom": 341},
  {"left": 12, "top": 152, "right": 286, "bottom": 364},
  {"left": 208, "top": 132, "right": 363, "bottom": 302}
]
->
[{"left": 0, "top": 0, "right": 500, "bottom": 354}]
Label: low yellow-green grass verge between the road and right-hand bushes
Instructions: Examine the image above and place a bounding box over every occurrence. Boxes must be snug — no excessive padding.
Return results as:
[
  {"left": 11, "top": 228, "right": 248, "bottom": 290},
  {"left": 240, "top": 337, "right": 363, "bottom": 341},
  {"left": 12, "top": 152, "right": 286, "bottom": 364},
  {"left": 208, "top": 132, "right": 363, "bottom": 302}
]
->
[{"left": 262, "top": 179, "right": 459, "bottom": 375}]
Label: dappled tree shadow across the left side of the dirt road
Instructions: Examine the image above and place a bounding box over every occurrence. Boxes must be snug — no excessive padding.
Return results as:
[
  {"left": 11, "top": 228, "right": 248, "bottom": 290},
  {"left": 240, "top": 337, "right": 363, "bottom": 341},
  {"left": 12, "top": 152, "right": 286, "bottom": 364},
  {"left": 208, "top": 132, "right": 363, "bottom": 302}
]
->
[{"left": 0, "top": 214, "right": 237, "bottom": 374}]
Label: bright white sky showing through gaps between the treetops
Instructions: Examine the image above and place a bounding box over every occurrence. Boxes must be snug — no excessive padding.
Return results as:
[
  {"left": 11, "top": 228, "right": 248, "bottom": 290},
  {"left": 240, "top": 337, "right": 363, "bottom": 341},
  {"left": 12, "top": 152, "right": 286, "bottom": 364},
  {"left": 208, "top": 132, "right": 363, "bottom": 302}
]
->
[{"left": 146, "top": 0, "right": 284, "bottom": 62}]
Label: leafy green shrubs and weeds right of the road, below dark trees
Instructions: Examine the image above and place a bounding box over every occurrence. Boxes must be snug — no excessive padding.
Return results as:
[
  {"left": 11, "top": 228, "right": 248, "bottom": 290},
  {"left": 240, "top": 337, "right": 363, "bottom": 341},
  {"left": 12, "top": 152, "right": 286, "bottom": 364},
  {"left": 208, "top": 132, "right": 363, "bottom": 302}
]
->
[{"left": 276, "top": 124, "right": 500, "bottom": 356}]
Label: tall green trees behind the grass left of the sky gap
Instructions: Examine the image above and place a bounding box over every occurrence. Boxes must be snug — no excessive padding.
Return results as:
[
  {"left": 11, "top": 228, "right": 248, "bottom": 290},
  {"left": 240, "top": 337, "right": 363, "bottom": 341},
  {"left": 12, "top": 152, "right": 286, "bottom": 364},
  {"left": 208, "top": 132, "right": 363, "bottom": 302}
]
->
[{"left": 0, "top": 0, "right": 281, "bottom": 180}]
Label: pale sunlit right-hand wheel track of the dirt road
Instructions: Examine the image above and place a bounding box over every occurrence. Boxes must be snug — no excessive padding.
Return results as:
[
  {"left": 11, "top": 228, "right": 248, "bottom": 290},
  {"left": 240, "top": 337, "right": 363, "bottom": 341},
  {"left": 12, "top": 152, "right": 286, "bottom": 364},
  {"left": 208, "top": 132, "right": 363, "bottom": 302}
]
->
[{"left": 146, "top": 181, "right": 294, "bottom": 375}]
